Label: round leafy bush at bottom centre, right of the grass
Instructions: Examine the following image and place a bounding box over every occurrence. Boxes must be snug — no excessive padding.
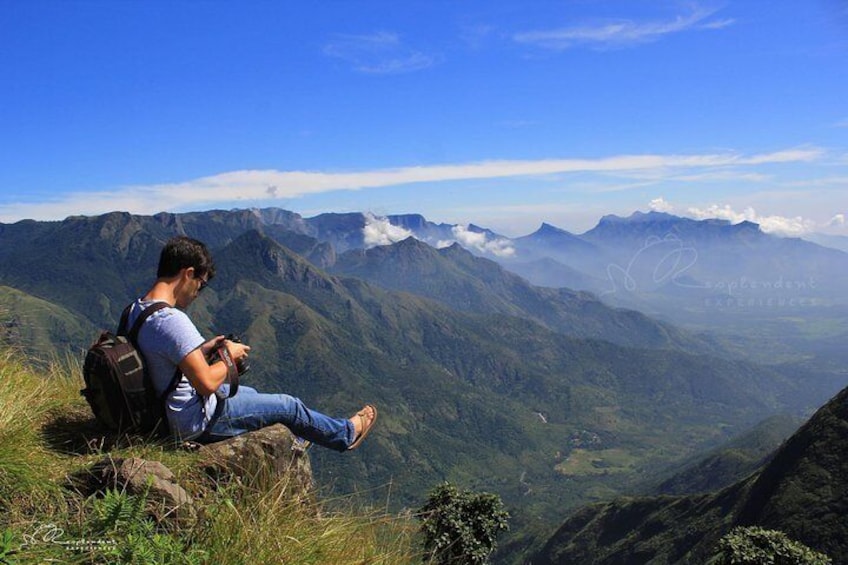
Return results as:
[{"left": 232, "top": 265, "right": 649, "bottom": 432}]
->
[{"left": 419, "top": 483, "right": 509, "bottom": 565}]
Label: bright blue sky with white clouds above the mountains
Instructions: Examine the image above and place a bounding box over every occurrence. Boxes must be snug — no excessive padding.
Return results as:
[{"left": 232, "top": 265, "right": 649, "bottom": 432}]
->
[{"left": 0, "top": 0, "right": 848, "bottom": 236}]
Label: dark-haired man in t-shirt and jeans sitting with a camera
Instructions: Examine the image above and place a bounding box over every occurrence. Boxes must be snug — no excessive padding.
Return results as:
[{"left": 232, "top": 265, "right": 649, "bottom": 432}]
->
[{"left": 126, "top": 236, "right": 377, "bottom": 451}]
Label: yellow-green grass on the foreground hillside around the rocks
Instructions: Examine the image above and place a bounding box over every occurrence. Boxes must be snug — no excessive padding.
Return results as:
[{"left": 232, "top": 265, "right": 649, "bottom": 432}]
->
[{"left": 0, "top": 349, "right": 421, "bottom": 565}]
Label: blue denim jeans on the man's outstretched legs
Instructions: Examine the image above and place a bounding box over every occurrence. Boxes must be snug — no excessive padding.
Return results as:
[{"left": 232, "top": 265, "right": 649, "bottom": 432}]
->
[{"left": 198, "top": 384, "right": 355, "bottom": 451}]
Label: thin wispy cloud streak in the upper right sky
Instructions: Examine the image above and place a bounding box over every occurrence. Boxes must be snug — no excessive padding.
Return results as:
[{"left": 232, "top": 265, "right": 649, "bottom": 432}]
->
[{"left": 513, "top": 6, "right": 734, "bottom": 51}]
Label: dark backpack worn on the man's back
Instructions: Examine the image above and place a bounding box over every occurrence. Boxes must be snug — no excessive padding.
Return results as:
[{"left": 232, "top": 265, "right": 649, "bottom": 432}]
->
[{"left": 80, "top": 302, "right": 182, "bottom": 435}]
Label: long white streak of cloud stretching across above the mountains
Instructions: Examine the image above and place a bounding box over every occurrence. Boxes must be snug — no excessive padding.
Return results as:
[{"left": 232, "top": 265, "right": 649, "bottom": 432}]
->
[{"left": 0, "top": 147, "right": 824, "bottom": 222}]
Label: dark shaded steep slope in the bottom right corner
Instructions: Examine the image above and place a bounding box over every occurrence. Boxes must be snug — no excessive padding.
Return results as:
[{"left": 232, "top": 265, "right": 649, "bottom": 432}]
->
[{"left": 533, "top": 382, "right": 848, "bottom": 565}]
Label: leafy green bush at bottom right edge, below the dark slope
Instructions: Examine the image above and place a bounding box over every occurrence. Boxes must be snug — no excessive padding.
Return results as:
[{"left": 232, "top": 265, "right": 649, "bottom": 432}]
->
[{"left": 711, "top": 526, "right": 831, "bottom": 565}]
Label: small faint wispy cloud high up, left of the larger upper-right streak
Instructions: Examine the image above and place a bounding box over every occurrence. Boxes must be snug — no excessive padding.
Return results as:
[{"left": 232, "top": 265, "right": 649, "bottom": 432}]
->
[{"left": 324, "top": 31, "right": 437, "bottom": 75}]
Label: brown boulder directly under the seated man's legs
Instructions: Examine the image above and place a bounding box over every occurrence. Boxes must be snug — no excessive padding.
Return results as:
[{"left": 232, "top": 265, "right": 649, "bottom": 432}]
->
[{"left": 200, "top": 424, "right": 314, "bottom": 504}]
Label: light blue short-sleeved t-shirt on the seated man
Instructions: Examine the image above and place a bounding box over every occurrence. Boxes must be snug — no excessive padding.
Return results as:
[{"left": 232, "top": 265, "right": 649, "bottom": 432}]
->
[{"left": 127, "top": 299, "right": 218, "bottom": 440}]
